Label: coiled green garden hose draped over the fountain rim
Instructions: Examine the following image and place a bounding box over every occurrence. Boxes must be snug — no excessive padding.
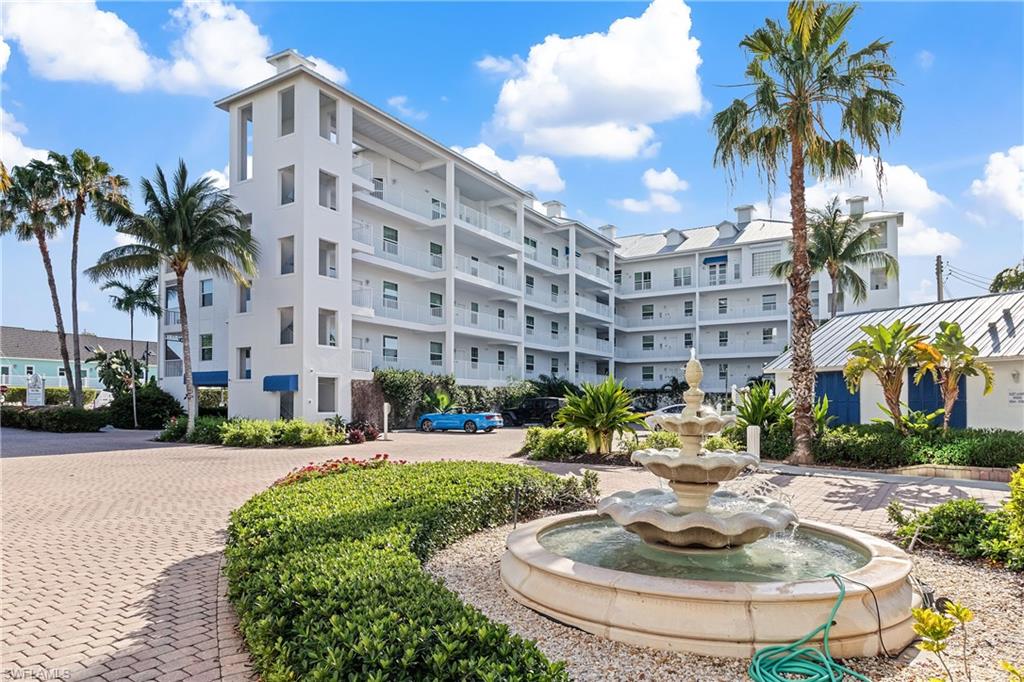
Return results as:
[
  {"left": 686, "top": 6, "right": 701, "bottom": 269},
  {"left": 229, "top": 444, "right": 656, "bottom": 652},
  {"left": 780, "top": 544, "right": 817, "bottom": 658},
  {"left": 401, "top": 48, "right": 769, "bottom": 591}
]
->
[{"left": 746, "top": 573, "right": 870, "bottom": 682}]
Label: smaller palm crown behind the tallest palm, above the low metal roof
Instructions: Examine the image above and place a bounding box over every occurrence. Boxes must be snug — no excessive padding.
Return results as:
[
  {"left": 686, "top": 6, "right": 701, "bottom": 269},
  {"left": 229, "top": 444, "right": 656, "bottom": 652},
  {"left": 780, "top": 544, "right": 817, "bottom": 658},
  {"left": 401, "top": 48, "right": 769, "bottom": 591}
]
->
[{"left": 771, "top": 197, "right": 899, "bottom": 317}]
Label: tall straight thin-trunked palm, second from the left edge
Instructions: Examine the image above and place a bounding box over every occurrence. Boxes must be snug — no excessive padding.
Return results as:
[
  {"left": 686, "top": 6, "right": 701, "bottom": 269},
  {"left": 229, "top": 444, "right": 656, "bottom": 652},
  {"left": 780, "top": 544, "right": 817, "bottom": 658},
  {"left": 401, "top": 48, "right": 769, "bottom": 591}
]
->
[{"left": 49, "top": 150, "right": 134, "bottom": 408}]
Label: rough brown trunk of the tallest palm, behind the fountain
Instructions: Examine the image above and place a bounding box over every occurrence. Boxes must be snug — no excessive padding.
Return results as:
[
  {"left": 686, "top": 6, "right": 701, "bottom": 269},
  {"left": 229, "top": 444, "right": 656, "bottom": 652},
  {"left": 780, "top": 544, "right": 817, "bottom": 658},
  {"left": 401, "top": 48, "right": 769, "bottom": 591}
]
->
[{"left": 788, "top": 131, "right": 815, "bottom": 464}]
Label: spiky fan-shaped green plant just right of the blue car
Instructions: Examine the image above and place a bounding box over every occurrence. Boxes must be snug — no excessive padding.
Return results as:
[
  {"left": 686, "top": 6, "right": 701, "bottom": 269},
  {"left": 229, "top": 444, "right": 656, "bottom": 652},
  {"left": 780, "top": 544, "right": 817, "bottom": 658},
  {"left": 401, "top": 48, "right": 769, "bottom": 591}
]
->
[{"left": 555, "top": 377, "right": 643, "bottom": 455}]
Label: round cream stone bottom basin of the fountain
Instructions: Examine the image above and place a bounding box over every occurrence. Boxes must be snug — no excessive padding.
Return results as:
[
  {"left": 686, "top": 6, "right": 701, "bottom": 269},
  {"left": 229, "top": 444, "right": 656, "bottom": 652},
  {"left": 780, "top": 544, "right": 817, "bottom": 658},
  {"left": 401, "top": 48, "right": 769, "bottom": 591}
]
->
[{"left": 501, "top": 512, "right": 921, "bottom": 657}]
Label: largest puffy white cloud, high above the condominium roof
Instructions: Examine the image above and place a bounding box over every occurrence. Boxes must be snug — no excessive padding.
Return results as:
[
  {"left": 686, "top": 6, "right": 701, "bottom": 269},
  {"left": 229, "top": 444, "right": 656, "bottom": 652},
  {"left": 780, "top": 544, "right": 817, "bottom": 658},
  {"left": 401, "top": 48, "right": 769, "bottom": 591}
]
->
[{"left": 487, "top": 0, "right": 706, "bottom": 159}]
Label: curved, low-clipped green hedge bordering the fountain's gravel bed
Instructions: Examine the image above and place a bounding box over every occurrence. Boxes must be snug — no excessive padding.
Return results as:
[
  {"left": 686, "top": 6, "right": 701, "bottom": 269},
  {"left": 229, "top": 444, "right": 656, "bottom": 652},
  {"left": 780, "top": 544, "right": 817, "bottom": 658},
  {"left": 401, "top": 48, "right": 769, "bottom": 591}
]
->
[{"left": 225, "top": 462, "right": 591, "bottom": 682}]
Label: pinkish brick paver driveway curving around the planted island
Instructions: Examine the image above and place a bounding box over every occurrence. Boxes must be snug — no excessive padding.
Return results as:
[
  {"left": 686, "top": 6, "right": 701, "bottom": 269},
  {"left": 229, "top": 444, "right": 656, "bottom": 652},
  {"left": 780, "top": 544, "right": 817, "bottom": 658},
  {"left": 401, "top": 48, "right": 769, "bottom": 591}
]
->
[{"left": 0, "top": 429, "right": 1005, "bottom": 680}]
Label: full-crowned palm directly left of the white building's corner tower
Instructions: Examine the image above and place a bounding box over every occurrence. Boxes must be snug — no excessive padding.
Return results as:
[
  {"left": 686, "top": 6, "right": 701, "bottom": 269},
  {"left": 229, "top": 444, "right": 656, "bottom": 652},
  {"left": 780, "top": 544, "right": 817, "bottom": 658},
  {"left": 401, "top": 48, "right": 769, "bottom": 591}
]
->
[{"left": 86, "top": 161, "right": 259, "bottom": 432}]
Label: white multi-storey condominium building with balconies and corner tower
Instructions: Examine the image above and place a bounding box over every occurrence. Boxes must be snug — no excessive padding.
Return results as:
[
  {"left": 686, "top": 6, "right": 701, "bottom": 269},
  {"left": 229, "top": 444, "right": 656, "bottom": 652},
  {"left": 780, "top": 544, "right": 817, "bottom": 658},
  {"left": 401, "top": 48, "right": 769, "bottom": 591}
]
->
[{"left": 160, "top": 50, "right": 901, "bottom": 420}]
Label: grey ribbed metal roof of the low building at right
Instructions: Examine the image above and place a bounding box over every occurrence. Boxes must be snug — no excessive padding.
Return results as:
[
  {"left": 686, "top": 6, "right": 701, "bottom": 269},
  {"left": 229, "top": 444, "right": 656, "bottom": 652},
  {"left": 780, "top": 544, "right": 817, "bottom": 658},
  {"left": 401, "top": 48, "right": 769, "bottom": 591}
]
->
[{"left": 765, "top": 291, "right": 1024, "bottom": 374}]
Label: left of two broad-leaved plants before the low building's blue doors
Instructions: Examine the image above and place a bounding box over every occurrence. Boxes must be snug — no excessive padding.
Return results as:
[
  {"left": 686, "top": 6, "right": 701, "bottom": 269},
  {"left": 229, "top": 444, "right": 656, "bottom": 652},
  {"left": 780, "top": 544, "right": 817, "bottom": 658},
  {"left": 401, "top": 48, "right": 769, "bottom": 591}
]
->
[{"left": 843, "top": 319, "right": 925, "bottom": 433}]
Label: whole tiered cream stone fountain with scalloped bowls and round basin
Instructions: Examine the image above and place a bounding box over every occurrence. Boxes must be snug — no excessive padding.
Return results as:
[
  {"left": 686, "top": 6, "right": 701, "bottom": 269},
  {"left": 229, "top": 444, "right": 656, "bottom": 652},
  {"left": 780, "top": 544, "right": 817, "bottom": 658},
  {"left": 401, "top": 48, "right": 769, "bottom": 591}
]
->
[{"left": 501, "top": 355, "right": 921, "bottom": 657}]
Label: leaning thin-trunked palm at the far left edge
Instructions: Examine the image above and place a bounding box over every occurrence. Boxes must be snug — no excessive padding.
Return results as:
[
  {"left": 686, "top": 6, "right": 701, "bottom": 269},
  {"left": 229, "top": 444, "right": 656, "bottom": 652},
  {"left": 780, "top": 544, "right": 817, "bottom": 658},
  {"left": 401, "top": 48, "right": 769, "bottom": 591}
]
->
[{"left": 0, "top": 160, "right": 74, "bottom": 389}]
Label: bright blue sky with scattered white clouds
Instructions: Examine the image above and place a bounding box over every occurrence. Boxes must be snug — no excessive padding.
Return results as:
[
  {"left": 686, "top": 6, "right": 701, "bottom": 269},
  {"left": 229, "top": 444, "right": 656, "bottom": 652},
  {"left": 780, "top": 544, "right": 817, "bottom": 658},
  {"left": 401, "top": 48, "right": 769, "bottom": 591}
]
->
[{"left": 0, "top": 0, "right": 1024, "bottom": 338}]
